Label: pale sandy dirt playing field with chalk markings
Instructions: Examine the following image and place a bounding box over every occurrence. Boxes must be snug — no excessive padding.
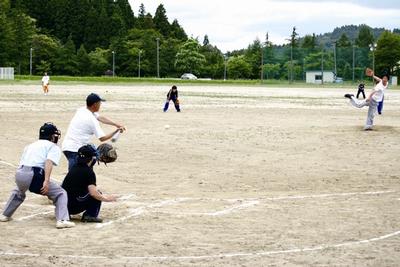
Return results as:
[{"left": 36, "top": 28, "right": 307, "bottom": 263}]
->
[{"left": 0, "top": 84, "right": 400, "bottom": 266}]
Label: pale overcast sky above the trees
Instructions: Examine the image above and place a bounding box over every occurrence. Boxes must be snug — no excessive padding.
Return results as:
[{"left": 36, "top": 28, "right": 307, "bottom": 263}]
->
[{"left": 130, "top": 0, "right": 400, "bottom": 52}]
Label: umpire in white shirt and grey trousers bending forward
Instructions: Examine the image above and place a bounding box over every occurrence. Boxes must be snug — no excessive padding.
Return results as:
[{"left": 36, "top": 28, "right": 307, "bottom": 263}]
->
[{"left": 0, "top": 123, "right": 75, "bottom": 228}]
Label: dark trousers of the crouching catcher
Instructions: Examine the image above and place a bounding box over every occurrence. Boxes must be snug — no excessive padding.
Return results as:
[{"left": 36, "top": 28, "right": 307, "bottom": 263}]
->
[{"left": 68, "top": 193, "right": 101, "bottom": 217}]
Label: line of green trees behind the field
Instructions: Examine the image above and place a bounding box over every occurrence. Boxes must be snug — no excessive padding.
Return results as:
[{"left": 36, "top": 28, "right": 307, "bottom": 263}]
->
[{"left": 0, "top": 0, "right": 400, "bottom": 80}]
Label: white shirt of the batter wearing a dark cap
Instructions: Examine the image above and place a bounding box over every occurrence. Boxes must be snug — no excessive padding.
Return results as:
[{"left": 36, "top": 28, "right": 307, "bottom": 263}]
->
[{"left": 62, "top": 107, "right": 105, "bottom": 152}]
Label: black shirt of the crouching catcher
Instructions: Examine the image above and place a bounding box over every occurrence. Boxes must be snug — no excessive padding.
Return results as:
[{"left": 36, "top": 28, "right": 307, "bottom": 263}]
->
[{"left": 61, "top": 164, "right": 96, "bottom": 199}]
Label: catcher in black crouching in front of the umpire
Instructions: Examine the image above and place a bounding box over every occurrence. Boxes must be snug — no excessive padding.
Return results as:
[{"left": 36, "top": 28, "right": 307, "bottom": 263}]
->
[{"left": 62, "top": 144, "right": 116, "bottom": 223}]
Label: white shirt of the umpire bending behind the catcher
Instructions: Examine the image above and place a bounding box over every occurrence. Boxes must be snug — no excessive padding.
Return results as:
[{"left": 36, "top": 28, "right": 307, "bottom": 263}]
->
[{"left": 19, "top": 140, "right": 61, "bottom": 169}]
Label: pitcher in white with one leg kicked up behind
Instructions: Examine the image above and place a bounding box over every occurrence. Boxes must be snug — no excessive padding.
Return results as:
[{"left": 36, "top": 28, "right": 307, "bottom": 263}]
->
[{"left": 344, "top": 68, "right": 389, "bottom": 130}]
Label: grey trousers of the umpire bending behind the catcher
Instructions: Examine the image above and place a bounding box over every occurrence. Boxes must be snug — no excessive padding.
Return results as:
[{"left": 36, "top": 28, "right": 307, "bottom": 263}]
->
[{"left": 3, "top": 166, "right": 69, "bottom": 221}]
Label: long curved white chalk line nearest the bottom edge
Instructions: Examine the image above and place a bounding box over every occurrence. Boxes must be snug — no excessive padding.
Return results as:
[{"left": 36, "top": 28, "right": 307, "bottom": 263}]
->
[{"left": 0, "top": 231, "right": 400, "bottom": 261}]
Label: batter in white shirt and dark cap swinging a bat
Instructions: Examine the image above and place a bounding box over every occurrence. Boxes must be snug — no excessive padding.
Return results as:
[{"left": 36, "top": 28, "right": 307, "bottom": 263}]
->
[{"left": 62, "top": 93, "right": 125, "bottom": 170}]
